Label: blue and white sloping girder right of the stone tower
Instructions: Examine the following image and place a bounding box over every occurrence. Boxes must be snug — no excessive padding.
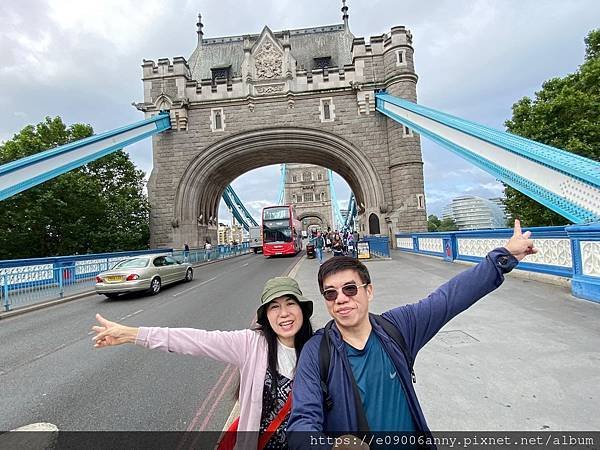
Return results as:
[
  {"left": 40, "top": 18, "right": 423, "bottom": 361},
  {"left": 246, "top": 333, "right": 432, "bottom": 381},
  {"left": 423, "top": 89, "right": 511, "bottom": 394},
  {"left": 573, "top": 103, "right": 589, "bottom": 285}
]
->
[{"left": 376, "top": 92, "right": 600, "bottom": 223}]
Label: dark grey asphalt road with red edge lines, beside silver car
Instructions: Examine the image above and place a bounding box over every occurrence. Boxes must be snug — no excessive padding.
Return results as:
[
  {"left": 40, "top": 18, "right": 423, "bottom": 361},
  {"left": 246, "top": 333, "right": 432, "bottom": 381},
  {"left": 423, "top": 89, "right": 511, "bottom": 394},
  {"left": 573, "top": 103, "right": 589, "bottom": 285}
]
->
[{"left": 0, "top": 251, "right": 299, "bottom": 431}]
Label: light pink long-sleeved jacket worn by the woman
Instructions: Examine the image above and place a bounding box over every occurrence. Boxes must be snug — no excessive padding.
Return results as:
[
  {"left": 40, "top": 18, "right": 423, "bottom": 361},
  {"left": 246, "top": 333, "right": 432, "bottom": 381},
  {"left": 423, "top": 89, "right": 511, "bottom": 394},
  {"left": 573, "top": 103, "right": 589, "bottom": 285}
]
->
[{"left": 135, "top": 327, "right": 267, "bottom": 448}]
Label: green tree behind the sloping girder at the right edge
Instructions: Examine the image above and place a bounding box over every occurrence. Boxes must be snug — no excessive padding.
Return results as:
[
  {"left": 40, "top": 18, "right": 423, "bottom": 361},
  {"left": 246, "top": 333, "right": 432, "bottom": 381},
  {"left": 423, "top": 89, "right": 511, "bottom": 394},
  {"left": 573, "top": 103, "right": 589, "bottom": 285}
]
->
[{"left": 504, "top": 29, "right": 600, "bottom": 226}]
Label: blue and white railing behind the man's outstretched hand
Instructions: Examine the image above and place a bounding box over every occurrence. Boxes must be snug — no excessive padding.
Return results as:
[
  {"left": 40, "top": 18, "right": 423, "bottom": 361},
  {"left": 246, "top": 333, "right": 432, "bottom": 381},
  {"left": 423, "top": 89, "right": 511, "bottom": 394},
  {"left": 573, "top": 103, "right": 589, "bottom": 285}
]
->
[{"left": 395, "top": 223, "right": 600, "bottom": 302}]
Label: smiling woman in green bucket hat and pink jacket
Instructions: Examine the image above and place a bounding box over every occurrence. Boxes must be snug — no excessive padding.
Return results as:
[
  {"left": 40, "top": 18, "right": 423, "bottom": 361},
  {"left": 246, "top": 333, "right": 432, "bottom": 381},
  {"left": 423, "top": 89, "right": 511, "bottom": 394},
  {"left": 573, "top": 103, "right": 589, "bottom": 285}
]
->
[{"left": 92, "top": 277, "right": 313, "bottom": 450}]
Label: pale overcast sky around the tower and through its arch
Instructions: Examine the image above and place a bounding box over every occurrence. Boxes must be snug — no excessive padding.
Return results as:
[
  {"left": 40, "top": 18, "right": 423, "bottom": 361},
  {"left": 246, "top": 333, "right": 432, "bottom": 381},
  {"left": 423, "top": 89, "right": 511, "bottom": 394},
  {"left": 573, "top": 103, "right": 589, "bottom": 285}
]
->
[{"left": 0, "top": 0, "right": 600, "bottom": 225}]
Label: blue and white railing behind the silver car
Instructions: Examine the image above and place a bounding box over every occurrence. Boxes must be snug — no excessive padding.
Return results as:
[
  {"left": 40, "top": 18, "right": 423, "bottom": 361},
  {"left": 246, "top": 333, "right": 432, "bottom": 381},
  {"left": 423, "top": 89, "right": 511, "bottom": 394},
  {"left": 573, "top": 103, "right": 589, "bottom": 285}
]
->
[{"left": 0, "top": 242, "right": 250, "bottom": 311}]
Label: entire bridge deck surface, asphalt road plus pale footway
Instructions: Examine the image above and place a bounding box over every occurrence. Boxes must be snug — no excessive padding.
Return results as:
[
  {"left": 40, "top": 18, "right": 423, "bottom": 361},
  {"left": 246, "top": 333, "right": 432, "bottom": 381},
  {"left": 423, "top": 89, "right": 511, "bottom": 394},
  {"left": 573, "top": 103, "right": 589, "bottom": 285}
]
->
[{"left": 0, "top": 252, "right": 600, "bottom": 431}]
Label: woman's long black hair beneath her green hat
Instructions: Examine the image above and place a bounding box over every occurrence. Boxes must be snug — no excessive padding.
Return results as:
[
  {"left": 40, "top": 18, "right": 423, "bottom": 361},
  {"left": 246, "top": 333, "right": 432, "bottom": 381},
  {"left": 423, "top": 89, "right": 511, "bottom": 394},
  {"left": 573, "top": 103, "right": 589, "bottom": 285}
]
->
[{"left": 235, "top": 295, "right": 313, "bottom": 409}]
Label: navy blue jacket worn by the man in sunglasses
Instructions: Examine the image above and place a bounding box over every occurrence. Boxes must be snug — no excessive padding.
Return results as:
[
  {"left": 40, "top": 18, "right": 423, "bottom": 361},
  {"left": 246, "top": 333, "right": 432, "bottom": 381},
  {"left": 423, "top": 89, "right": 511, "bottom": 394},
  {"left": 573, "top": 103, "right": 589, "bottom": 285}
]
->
[{"left": 287, "top": 248, "right": 518, "bottom": 449}]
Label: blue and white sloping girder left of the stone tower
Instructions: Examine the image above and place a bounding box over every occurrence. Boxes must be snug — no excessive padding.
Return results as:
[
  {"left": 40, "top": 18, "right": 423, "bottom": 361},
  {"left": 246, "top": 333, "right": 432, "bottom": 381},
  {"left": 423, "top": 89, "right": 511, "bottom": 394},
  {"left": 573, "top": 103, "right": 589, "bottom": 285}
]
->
[{"left": 0, "top": 113, "right": 171, "bottom": 200}]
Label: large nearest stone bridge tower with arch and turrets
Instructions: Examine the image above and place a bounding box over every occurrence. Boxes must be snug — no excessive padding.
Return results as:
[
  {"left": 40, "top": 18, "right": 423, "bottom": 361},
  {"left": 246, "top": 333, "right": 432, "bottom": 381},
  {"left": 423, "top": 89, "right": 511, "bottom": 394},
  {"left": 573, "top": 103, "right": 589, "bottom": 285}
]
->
[{"left": 135, "top": 4, "right": 426, "bottom": 247}]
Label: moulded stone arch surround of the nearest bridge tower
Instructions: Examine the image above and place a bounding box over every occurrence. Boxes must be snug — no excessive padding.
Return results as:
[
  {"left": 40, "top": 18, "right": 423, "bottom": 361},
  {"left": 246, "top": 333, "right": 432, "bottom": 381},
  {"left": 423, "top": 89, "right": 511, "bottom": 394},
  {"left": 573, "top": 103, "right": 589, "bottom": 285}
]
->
[{"left": 161, "top": 127, "right": 385, "bottom": 245}]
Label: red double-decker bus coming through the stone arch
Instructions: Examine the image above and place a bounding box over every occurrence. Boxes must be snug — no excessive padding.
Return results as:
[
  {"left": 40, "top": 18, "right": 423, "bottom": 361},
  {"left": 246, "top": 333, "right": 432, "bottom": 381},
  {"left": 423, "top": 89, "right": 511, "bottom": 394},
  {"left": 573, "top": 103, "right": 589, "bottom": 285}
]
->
[{"left": 262, "top": 205, "right": 302, "bottom": 256}]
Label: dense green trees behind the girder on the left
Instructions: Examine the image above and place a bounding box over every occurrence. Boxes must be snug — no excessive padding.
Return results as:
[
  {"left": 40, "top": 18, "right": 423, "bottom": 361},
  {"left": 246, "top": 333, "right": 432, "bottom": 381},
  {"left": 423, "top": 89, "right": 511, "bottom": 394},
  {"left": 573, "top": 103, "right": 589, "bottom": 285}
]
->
[{"left": 0, "top": 117, "right": 149, "bottom": 259}]
